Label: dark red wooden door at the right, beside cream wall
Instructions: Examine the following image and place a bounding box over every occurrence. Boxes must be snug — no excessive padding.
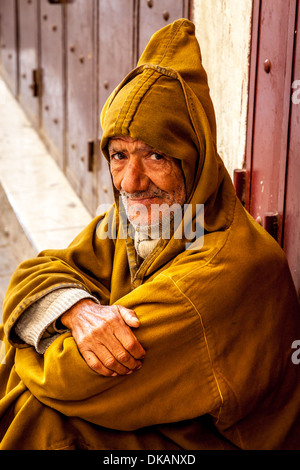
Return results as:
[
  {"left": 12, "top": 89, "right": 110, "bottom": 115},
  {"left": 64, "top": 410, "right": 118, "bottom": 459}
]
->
[{"left": 246, "top": 0, "right": 300, "bottom": 293}]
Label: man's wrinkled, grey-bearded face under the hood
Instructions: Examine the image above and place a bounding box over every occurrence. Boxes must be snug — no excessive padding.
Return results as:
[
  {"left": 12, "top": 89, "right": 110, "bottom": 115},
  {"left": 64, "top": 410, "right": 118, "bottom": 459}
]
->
[{"left": 108, "top": 136, "right": 186, "bottom": 226}]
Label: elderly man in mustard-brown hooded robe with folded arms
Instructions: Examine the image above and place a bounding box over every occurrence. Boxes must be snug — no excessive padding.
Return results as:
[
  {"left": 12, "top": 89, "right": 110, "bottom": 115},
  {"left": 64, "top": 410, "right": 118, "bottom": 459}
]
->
[{"left": 0, "top": 20, "right": 300, "bottom": 450}]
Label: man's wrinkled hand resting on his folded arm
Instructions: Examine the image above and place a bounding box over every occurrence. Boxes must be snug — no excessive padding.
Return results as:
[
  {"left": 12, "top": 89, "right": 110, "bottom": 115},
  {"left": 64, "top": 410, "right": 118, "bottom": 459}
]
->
[{"left": 61, "top": 299, "right": 146, "bottom": 376}]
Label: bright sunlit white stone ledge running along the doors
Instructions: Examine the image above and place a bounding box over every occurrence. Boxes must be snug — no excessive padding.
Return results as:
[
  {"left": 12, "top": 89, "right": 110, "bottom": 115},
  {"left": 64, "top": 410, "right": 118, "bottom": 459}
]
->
[{"left": 0, "top": 78, "right": 91, "bottom": 255}]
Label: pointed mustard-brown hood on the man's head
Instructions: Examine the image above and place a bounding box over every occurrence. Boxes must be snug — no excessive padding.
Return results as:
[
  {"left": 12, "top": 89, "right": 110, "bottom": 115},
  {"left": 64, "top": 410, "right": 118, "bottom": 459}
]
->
[{"left": 101, "top": 19, "right": 236, "bottom": 242}]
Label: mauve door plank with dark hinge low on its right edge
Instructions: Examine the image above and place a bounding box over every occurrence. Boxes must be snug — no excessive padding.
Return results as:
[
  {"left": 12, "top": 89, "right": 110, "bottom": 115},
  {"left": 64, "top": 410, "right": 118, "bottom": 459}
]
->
[{"left": 66, "top": 0, "right": 97, "bottom": 213}]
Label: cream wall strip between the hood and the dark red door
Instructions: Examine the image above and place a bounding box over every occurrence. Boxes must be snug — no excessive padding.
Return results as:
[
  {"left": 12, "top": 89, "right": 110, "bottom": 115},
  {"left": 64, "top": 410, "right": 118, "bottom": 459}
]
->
[{"left": 193, "top": 0, "right": 252, "bottom": 177}]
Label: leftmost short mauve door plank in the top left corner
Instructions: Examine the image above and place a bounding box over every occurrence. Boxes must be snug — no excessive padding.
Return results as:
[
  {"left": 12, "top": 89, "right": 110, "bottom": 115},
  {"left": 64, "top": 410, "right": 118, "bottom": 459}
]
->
[{"left": 0, "top": 0, "right": 18, "bottom": 96}]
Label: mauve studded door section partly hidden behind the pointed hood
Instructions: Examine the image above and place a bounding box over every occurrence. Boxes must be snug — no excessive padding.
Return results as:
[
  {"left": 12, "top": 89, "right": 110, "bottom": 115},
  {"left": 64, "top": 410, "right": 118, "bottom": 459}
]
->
[{"left": 96, "top": 0, "right": 190, "bottom": 211}]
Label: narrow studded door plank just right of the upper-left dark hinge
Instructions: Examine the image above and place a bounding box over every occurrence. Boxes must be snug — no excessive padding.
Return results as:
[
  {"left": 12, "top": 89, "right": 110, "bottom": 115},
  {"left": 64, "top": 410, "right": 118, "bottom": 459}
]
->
[{"left": 39, "top": 0, "right": 65, "bottom": 169}]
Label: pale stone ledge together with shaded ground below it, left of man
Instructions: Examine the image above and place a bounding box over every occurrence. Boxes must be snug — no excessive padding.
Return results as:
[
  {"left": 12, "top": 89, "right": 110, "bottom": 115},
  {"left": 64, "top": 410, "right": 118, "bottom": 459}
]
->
[{"left": 0, "top": 77, "right": 92, "bottom": 324}]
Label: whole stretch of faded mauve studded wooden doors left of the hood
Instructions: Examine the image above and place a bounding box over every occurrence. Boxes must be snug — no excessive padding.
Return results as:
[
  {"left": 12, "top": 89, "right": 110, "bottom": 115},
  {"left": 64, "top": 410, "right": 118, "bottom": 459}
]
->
[{"left": 0, "top": 0, "right": 190, "bottom": 214}]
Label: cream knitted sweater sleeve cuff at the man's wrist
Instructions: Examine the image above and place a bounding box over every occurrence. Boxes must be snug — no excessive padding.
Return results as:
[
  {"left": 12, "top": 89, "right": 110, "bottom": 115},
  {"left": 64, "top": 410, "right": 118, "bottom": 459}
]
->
[{"left": 14, "top": 288, "right": 99, "bottom": 354}]
